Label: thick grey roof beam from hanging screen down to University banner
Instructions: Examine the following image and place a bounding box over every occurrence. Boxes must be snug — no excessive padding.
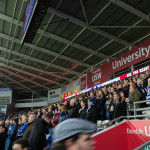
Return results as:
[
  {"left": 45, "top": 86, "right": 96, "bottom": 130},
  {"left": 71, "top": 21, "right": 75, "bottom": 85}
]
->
[{"left": 48, "top": 7, "right": 130, "bottom": 46}]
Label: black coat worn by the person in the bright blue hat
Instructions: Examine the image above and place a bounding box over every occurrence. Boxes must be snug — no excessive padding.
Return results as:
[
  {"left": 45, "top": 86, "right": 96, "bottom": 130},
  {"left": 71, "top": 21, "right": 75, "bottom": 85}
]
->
[{"left": 85, "top": 105, "right": 98, "bottom": 123}]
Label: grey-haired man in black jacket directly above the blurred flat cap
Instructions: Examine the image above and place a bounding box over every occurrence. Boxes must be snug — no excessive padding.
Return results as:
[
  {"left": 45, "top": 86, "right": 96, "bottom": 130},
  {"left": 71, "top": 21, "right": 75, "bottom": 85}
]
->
[{"left": 68, "top": 98, "right": 79, "bottom": 118}]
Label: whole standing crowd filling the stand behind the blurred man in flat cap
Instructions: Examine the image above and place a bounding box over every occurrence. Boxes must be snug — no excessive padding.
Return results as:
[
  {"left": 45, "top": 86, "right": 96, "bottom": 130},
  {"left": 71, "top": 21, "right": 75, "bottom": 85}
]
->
[{"left": 0, "top": 71, "right": 150, "bottom": 150}]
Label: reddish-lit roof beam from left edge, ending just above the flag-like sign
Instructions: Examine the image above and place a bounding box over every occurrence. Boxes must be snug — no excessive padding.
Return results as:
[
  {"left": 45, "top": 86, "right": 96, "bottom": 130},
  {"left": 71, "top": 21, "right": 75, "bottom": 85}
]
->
[{"left": 0, "top": 67, "right": 48, "bottom": 89}]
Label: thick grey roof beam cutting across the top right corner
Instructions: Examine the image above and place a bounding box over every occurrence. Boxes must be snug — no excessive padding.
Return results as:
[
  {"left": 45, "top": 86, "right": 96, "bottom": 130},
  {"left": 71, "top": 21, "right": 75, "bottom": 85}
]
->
[{"left": 109, "top": 0, "right": 150, "bottom": 22}]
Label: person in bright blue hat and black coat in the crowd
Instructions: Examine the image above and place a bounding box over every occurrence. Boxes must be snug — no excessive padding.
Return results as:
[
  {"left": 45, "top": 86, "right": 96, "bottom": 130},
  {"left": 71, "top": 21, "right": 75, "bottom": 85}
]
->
[{"left": 85, "top": 98, "right": 98, "bottom": 123}]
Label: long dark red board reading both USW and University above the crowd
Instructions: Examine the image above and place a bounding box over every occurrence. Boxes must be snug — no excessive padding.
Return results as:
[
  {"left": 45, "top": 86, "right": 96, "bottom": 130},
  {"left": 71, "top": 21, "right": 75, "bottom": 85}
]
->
[{"left": 84, "top": 40, "right": 150, "bottom": 88}]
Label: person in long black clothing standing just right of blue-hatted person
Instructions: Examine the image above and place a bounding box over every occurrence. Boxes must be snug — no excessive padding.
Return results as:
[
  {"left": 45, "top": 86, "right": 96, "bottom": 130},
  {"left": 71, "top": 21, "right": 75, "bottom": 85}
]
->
[{"left": 97, "top": 90, "right": 106, "bottom": 121}]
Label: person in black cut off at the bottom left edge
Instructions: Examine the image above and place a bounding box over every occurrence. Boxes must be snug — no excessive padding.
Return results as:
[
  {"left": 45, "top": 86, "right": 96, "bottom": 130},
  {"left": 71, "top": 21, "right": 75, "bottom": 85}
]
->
[{"left": 0, "top": 121, "right": 7, "bottom": 150}]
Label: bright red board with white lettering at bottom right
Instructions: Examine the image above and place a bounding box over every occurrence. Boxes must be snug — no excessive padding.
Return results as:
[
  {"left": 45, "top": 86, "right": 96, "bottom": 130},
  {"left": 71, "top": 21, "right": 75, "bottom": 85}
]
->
[{"left": 93, "top": 120, "right": 150, "bottom": 150}]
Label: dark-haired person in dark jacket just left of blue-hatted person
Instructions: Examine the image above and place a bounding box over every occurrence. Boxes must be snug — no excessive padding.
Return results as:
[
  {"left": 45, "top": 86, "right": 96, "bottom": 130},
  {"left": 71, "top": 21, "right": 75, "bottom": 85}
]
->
[{"left": 79, "top": 99, "right": 87, "bottom": 119}]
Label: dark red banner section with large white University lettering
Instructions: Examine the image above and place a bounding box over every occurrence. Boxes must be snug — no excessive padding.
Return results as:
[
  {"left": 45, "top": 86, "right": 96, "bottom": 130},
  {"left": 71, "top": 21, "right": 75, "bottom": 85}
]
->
[{"left": 104, "top": 40, "right": 150, "bottom": 74}]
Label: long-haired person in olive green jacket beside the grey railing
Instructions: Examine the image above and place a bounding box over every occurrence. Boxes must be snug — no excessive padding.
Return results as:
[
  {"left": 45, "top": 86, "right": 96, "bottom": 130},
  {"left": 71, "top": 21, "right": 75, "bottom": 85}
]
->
[{"left": 125, "top": 85, "right": 141, "bottom": 109}]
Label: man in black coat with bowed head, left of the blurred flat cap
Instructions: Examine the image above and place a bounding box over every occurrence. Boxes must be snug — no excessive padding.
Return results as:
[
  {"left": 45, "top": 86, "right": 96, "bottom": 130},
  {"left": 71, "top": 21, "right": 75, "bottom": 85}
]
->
[{"left": 29, "top": 114, "right": 53, "bottom": 150}]
